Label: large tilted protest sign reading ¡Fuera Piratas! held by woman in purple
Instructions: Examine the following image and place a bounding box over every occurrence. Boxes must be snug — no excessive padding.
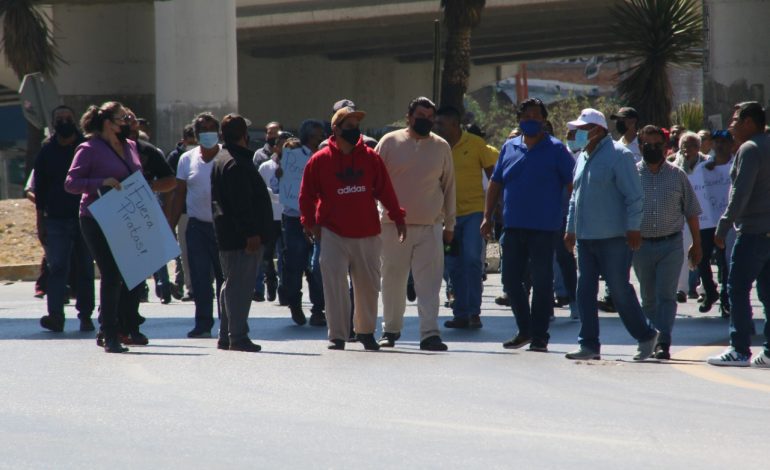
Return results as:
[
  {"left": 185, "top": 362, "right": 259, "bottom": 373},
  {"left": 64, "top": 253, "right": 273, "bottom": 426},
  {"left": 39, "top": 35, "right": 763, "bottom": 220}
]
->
[{"left": 88, "top": 171, "right": 180, "bottom": 289}]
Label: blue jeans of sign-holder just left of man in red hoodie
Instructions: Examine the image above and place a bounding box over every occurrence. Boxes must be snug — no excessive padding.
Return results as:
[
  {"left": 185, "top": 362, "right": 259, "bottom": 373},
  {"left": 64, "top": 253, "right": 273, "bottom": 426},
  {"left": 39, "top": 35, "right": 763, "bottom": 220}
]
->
[{"left": 281, "top": 215, "right": 324, "bottom": 313}]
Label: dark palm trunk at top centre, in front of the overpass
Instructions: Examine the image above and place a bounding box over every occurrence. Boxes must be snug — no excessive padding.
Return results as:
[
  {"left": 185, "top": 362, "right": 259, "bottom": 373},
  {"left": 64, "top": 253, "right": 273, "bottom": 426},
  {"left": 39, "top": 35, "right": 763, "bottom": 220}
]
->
[{"left": 441, "top": 0, "right": 486, "bottom": 112}]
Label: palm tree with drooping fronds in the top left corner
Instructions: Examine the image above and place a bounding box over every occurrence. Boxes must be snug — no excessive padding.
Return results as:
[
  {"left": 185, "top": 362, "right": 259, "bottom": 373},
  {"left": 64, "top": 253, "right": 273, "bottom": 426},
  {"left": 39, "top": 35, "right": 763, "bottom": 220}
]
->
[{"left": 0, "top": 0, "right": 62, "bottom": 174}]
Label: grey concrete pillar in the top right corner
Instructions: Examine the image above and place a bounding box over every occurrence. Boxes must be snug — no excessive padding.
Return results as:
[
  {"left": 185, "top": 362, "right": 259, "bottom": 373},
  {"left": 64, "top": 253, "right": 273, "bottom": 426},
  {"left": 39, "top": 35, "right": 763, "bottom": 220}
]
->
[{"left": 704, "top": 0, "right": 770, "bottom": 128}]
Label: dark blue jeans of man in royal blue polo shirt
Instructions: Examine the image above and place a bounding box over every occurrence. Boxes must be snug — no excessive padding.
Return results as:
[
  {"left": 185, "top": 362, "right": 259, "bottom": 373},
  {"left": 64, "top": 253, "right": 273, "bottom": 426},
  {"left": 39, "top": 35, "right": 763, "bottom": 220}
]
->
[{"left": 502, "top": 228, "right": 556, "bottom": 343}]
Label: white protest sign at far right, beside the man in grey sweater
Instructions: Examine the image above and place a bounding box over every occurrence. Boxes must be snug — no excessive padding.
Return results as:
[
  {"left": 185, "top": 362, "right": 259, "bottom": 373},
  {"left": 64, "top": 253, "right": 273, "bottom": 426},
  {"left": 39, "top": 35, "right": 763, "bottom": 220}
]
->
[{"left": 690, "top": 163, "right": 731, "bottom": 228}]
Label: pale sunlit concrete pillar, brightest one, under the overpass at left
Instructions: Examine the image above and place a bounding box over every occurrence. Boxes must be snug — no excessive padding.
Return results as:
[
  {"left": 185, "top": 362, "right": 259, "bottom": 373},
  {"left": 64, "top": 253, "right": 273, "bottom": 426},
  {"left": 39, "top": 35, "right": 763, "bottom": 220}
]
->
[{"left": 154, "top": 0, "right": 238, "bottom": 150}]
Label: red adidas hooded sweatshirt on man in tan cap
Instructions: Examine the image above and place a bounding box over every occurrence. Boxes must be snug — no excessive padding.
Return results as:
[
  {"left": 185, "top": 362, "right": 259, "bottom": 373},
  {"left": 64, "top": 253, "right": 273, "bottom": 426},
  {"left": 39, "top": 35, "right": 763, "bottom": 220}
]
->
[{"left": 299, "top": 137, "right": 406, "bottom": 238}]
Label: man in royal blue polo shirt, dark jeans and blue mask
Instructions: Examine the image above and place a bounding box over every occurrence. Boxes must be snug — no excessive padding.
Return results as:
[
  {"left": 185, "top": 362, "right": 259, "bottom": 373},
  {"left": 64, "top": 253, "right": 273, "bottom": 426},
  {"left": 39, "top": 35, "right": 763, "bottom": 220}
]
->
[{"left": 481, "top": 99, "right": 575, "bottom": 352}]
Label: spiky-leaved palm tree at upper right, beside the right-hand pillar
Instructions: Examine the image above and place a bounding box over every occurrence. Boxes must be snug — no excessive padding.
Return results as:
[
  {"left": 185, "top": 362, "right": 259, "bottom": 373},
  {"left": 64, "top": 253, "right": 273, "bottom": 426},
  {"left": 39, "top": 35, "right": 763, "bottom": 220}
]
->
[{"left": 612, "top": 0, "right": 703, "bottom": 127}]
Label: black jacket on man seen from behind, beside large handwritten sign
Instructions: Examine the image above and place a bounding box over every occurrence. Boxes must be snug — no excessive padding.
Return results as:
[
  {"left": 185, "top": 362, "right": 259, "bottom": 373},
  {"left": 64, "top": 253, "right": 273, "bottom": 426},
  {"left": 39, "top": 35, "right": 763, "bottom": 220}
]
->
[{"left": 211, "top": 145, "right": 275, "bottom": 251}]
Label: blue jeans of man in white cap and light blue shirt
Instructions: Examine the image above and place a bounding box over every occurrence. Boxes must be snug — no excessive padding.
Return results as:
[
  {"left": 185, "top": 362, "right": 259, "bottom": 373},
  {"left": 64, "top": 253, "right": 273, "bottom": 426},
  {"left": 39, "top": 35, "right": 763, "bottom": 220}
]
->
[{"left": 577, "top": 237, "right": 655, "bottom": 352}]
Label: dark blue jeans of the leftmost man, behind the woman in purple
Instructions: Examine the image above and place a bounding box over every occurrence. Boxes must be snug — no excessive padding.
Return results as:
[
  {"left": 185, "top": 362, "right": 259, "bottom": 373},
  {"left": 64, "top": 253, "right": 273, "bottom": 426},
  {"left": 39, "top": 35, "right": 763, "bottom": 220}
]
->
[{"left": 45, "top": 217, "right": 95, "bottom": 318}]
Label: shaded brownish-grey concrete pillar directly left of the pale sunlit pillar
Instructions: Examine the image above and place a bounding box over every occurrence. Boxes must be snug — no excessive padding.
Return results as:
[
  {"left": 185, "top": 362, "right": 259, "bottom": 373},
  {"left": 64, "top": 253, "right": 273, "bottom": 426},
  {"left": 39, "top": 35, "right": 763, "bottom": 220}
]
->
[{"left": 52, "top": 2, "right": 155, "bottom": 130}]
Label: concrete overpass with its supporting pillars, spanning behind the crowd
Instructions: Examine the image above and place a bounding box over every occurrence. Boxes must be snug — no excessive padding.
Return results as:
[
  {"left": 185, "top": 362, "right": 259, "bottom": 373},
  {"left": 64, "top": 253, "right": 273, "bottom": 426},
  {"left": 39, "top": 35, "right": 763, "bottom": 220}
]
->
[{"left": 0, "top": 0, "right": 770, "bottom": 152}]
